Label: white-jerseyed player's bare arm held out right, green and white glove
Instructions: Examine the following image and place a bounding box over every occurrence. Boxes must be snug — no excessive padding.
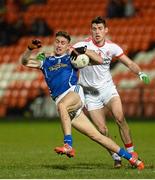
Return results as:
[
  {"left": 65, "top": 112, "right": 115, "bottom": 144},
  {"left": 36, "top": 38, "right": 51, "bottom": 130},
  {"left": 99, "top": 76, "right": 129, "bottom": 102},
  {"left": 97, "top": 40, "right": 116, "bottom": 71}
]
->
[{"left": 120, "top": 55, "right": 150, "bottom": 84}]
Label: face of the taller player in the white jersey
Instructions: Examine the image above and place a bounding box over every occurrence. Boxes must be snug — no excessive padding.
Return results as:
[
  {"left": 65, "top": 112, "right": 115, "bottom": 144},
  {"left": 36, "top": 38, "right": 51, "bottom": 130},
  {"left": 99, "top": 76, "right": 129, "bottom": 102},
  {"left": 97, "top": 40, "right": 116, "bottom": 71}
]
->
[{"left": 91, "top": 23, "right": 108, "bottom": 45}]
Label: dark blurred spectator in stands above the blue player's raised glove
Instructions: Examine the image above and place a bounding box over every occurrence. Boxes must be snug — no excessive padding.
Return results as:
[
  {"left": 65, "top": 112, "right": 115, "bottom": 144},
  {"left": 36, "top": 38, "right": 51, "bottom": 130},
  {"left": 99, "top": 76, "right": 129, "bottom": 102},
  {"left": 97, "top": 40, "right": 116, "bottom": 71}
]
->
[{"left": 30, "top": 17, "right": 54, "bottom": 36}]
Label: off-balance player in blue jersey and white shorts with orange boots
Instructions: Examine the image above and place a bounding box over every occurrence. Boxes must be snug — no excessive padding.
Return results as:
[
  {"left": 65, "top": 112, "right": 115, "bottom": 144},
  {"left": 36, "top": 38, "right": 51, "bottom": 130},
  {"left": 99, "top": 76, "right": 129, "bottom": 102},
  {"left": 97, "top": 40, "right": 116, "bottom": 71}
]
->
[{"left": 22, "top": 31, "right": 142, "bottom": 169}]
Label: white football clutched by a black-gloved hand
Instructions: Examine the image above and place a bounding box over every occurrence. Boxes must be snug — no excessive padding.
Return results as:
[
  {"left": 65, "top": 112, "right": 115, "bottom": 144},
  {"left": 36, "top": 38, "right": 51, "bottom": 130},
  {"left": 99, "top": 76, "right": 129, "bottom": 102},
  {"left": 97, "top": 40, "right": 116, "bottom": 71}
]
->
[{"left": 72, "top": 54, "right": 89, "bottom": 68}]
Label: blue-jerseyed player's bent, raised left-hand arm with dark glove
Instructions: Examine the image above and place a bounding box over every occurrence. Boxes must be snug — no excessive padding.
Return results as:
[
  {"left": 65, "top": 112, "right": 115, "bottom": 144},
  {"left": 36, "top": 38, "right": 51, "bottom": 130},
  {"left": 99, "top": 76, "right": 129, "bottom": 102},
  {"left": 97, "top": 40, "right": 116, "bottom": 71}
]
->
[{"left": 21, "top": 40, "right": 41, "bottom": 68}]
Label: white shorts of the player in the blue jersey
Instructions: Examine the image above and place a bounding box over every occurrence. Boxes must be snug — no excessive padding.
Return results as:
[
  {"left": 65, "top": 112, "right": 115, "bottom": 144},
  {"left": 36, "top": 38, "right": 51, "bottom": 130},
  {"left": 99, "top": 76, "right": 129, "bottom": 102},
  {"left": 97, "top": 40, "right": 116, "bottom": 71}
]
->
[{"left": 55, "top": 85, "right": 85, "bottom": 117}]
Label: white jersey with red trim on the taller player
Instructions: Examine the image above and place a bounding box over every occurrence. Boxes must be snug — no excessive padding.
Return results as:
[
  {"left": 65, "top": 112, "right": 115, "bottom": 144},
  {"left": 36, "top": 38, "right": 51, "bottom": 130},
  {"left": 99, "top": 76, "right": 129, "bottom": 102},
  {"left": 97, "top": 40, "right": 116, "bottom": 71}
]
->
[{"left": 73, "top": 38, "right": 123, "bottom": 89}]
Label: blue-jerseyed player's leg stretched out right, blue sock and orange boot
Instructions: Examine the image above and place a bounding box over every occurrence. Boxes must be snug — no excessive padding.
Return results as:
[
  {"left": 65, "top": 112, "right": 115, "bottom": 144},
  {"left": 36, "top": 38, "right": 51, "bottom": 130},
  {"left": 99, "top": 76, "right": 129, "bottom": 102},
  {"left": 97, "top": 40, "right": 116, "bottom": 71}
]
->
[{"left": 72, "top": 112, "right": 144, "bottom": 170}]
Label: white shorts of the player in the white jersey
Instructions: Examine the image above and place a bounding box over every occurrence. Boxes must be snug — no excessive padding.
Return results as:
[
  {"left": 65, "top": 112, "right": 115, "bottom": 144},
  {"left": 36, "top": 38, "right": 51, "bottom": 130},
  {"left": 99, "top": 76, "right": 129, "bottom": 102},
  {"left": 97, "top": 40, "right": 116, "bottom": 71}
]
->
[{"left": 85, "top": 84, "right": 119, "bottom": 111}]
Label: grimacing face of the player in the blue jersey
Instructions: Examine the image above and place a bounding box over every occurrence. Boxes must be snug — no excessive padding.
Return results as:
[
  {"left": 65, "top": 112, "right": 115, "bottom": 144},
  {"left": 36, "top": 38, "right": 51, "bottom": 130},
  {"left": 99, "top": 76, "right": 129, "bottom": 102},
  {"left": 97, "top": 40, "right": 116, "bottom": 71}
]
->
[{"left": 54, "top": 36, "right": 69, "bottom": 56}]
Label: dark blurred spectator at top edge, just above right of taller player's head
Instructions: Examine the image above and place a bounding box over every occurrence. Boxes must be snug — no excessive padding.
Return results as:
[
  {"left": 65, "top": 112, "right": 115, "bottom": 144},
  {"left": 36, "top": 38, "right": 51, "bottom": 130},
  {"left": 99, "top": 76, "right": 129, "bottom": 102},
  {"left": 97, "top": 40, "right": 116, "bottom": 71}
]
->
[{"left": 107, "top": 0, "right": 125, "bottom": 18}]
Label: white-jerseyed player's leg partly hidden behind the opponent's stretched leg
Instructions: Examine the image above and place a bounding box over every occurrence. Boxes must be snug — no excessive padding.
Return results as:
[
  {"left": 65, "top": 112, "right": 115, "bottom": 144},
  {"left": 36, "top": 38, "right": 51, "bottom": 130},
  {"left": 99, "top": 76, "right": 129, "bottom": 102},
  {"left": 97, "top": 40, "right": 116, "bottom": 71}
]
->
[{"left": 89, "top": 108, "right": 121, "bottom": 168}]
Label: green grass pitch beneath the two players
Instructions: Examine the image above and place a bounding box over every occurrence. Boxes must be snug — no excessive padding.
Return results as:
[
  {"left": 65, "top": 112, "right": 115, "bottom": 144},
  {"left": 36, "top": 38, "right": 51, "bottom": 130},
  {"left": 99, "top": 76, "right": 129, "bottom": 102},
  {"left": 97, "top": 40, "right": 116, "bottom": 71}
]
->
[{"left": 0, "top": 119, "right": 155, "bottom": 179}]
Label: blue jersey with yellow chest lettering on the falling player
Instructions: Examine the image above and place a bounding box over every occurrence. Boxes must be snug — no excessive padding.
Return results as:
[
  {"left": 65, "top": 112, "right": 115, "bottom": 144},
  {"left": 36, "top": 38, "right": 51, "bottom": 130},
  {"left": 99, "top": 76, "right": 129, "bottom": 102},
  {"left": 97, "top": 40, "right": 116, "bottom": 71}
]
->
[{"left": 41, "top": 54, "right": 78, "bottom": 99}]
